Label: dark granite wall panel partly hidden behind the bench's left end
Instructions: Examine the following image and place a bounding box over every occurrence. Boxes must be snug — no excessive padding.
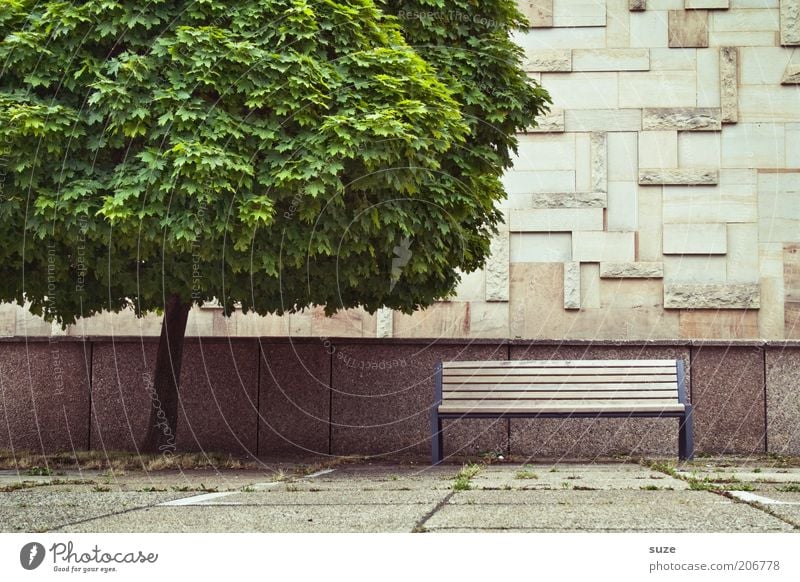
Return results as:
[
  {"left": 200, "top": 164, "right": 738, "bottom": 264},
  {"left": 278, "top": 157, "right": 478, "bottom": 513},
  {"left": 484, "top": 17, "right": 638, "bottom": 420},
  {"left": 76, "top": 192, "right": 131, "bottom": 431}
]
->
[{"left": 331, "top": 342, "right": 508, "bottom": 456}]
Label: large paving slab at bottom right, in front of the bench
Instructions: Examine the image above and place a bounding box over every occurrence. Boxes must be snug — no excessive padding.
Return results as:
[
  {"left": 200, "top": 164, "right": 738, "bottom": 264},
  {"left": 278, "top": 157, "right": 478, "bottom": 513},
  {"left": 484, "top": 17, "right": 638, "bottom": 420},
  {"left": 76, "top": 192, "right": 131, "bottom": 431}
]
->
[{"left": 425, "top": 491, "right": 794, "bottom": 532}]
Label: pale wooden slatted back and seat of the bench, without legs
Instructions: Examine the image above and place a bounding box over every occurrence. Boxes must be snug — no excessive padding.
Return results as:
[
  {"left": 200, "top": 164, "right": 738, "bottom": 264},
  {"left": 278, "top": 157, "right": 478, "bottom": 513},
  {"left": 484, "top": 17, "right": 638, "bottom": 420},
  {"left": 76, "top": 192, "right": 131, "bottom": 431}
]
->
[{"left": 437, "top": 360, "right": 687, "bottom": 414}]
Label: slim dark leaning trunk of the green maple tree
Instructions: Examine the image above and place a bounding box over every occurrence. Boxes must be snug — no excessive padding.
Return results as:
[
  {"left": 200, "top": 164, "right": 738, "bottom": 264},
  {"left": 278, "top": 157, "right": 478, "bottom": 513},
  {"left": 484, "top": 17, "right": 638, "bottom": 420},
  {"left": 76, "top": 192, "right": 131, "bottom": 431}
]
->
[{"left": 142, "top": 295, "right": 192, "bottom": 454}]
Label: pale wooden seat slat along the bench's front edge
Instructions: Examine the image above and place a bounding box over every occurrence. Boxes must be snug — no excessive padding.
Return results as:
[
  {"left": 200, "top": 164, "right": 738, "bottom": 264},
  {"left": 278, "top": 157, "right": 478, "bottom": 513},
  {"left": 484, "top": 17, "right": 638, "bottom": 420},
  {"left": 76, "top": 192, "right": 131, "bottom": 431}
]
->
[{"left": 439, "top": 400, "right": 685, "bottom": 414}]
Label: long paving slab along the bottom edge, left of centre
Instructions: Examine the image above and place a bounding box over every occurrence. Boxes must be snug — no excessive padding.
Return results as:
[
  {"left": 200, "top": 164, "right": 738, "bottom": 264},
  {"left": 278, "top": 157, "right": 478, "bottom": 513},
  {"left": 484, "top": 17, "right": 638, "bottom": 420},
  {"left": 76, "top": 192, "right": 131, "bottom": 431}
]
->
[{"left": 57, "top": 504, "right": 433, "bottom": 533}]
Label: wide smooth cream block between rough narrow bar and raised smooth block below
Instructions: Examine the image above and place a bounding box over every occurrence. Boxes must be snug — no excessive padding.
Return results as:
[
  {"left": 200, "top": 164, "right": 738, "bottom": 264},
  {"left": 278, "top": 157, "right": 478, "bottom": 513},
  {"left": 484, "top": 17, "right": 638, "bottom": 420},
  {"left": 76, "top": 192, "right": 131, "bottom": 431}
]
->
[{"left": 663, "top": 184, "right": 758, "bottom": 224}]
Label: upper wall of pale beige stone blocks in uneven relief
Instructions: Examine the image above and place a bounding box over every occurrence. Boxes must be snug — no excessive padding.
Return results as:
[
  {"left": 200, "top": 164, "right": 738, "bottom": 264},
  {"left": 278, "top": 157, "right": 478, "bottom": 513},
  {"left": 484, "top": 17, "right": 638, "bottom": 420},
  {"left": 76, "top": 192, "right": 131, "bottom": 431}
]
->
[{"left": 0, "top": 0, "right": 800, "bottom": 339}]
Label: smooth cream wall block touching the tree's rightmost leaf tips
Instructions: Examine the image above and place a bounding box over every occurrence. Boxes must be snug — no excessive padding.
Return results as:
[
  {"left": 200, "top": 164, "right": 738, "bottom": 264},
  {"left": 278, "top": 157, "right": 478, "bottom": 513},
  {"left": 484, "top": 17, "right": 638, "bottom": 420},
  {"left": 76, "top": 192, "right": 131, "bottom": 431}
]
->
[{"left": 542, "top": 72, "right": 620, "bottom": 110}]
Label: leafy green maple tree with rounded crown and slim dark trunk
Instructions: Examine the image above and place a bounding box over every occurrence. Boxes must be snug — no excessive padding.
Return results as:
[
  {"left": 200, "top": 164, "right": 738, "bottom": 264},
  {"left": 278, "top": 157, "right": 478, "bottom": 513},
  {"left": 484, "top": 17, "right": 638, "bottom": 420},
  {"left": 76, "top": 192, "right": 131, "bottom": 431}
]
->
[{"left": 0, "top": 0, "right": 548, "bottom": 452}]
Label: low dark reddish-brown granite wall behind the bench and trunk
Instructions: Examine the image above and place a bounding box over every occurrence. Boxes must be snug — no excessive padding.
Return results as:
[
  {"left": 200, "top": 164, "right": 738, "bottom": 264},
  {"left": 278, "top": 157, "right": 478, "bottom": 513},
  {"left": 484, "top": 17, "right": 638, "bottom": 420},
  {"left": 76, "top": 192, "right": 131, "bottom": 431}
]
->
[{"left": 0, "top": 338, "right": 800, "bottom": 459}]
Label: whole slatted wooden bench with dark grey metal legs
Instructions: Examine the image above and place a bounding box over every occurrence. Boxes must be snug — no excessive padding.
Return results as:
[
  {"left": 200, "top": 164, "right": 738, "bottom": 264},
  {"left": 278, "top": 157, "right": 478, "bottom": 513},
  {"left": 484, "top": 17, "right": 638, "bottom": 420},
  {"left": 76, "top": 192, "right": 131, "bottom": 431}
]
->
[{"left": 431, "top": 360, "right": 694, "bottom": 465}]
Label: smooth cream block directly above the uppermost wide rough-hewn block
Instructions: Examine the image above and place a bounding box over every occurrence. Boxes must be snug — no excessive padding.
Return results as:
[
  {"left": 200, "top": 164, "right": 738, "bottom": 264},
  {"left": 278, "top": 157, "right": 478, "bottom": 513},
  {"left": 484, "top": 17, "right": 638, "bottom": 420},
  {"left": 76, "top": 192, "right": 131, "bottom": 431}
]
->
[{"left": 618, "top": 71, "right": 697, "bottom": 107}]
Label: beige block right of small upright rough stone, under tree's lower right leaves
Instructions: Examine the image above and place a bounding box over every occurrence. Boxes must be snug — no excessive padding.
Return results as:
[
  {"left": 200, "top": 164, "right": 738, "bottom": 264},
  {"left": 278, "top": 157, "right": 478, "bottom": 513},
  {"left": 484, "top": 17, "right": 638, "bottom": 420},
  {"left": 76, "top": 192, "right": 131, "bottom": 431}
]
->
[{"left": 394, "top": 301, "right": 470, "bottom": 339}]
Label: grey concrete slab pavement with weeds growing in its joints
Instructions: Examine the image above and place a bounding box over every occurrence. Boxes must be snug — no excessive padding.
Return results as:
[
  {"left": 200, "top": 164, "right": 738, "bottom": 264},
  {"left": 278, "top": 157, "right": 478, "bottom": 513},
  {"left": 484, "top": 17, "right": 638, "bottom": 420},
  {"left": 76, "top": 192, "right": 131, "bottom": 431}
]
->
[{"left": 0, "top": 458, "right": 800, "bottom": 533}]
